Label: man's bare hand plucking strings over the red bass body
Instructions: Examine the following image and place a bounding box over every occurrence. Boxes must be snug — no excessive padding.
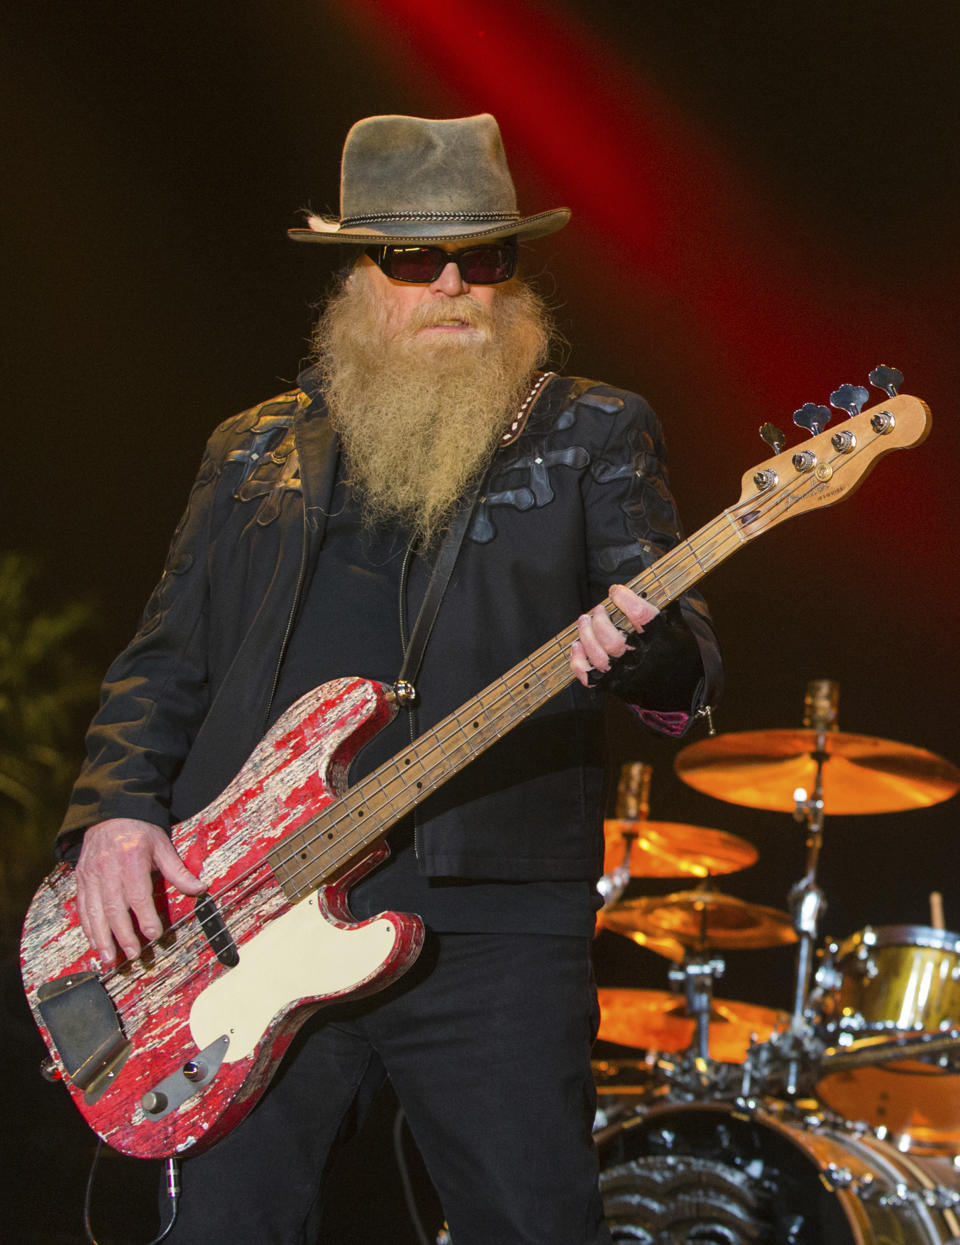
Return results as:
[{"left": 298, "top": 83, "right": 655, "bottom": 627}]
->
[{"left": 76, "top": 817, "right": 204, "bottom": 964}]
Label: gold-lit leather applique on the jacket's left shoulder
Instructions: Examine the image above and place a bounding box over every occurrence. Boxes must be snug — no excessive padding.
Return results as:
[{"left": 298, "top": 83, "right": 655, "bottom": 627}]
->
[{"left": 225, "top": 395, "right": 301, "bottom": 527}]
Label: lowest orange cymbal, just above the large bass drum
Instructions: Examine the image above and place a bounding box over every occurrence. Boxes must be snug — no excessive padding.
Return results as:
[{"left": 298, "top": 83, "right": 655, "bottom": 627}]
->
[{"left": 596, "top": 989, "right": 788, "bottom": 1063}]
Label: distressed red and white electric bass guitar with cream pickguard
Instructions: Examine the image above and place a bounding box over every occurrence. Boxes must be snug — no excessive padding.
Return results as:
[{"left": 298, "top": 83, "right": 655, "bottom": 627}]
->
[{"left": 21, "top": 369, "right": 930, "bottom": 1158}]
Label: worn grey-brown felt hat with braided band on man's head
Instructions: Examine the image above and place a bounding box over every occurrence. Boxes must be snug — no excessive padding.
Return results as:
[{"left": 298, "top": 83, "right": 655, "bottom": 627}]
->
[{"left": 288, "top": 112, "right": 570, "bottom": 247}]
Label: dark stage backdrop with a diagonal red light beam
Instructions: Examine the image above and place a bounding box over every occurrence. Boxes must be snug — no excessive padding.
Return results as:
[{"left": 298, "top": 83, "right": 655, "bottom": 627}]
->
[{"left": 0, "top": 0, "right": 960, "bottom": 1245}]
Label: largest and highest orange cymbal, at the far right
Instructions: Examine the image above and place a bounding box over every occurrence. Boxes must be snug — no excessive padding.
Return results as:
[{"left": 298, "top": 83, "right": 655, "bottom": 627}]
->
[{"left": 674, "top": 731, "right": 960, "bottom": 815}]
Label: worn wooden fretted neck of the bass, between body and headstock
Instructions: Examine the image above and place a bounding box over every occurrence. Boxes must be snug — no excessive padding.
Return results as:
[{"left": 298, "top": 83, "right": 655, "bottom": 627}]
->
[{"left": 270, "top": 510, "right": 748, "bottom": 899}]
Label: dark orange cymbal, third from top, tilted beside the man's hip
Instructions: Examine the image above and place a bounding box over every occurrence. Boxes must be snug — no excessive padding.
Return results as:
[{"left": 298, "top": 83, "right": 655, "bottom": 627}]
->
[{"left": 596, "top": 890, "right": 797, "bottom": 951}]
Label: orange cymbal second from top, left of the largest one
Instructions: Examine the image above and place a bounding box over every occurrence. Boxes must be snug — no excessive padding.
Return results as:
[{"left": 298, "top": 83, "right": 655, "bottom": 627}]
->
[{"left": 604, "top": 818, "right": 757, "bottom": 878}]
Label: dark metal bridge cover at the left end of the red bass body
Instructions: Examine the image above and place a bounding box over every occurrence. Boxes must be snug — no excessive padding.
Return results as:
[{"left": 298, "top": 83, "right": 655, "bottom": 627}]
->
[{"left": 36, "top": 972, "right": 132, "bottom": 1103}]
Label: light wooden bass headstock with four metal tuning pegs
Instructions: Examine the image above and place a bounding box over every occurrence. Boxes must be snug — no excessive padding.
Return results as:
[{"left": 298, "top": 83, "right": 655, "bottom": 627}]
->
[{"left": 727, "top": 367, "right": 931, "bottom": 540}]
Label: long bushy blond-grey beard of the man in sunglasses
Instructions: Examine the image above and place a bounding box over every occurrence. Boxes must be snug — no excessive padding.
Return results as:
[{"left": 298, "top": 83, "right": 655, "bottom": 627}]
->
[{"left": 314, "top": 270, "right": 553, "bottom": 548}]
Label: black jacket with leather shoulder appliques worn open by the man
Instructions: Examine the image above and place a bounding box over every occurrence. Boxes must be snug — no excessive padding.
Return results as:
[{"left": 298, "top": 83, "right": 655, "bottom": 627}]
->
[{"left": 60, "top": 371, "right": 720, "bottom": 879}]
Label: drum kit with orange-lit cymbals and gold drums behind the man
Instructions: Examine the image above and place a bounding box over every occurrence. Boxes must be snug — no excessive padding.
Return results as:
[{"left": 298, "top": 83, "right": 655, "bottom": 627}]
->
[{"left": 594, "top": 680, "right": 960, "bottom": 1245}]
